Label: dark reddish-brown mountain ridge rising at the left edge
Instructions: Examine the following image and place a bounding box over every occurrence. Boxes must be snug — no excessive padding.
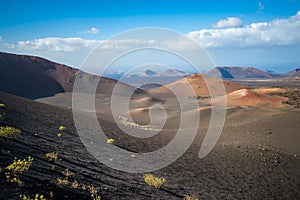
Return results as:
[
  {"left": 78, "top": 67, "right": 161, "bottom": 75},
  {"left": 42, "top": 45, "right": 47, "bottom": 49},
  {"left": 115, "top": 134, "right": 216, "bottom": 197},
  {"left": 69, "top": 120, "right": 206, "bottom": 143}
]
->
[{"left": 0, "top": 52, "right": 141, "bottom": 99}]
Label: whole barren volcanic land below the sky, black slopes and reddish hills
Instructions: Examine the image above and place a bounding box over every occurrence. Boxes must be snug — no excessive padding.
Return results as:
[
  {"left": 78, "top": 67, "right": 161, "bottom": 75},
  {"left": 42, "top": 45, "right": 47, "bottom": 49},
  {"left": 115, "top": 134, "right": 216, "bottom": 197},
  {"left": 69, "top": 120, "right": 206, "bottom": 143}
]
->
[{"left": 0, "top": 53, "right": 300, "bottom": 199}]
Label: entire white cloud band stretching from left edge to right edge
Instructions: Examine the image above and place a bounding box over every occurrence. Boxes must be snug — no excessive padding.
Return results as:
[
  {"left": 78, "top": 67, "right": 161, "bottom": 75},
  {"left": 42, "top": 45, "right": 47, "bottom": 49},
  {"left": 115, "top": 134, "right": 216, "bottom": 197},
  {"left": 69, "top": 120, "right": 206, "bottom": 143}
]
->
[{"left": 0, "top": 11, "right": 300, "bottom": 59}]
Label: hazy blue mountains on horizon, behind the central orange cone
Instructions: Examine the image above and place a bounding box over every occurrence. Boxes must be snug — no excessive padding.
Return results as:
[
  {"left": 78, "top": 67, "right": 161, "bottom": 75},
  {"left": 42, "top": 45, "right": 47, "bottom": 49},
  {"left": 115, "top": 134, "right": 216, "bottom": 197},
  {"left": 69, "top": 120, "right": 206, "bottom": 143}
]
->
[{"left": 127, "top": 69, "right": 189, "bottom": 77}]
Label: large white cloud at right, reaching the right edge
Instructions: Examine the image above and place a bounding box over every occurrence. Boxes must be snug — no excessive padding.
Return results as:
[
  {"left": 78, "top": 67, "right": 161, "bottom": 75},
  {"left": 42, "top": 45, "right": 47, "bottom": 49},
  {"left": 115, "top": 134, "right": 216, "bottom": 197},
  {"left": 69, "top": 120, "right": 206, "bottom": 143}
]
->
[{"left": 187, "top": 11, "right": 300, "bottom": 48}]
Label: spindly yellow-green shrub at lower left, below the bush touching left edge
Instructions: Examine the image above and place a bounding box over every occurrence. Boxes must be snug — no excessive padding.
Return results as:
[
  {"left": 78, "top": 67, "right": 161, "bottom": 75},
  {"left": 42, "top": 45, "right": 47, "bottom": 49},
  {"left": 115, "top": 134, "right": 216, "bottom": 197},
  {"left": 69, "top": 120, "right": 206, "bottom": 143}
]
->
[{"left": 5, "top": 156, "right": 33, "bottom": 186}]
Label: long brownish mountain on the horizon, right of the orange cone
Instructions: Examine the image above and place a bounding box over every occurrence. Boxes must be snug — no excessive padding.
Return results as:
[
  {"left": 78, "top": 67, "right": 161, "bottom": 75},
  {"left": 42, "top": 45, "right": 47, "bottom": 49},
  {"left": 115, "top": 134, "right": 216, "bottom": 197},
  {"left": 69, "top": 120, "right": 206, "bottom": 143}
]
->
[{"left": 207, "top": 67, "right": 275, "bottom": 79}]
